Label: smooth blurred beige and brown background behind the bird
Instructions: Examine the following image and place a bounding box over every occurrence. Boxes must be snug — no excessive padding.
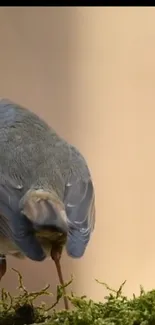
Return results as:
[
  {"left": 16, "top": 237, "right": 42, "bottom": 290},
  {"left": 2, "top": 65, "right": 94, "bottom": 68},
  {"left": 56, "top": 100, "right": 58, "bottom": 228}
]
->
[{"left": 0, "top": 7, "right": 155, "bottom": 306}]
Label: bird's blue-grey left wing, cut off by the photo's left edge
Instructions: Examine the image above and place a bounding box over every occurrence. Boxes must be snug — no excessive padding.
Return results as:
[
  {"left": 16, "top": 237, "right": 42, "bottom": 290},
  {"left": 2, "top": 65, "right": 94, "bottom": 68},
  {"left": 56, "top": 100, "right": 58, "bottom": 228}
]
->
[{"left": 0, "top": 175, "right": 45, "bottom": 261}]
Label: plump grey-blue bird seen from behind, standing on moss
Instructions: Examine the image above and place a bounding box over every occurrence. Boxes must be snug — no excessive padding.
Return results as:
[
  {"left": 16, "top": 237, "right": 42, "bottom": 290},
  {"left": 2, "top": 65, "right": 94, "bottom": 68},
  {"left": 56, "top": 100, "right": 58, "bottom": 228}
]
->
[{"left": 0, "top": 98, "right": 96, "bottom": 308}]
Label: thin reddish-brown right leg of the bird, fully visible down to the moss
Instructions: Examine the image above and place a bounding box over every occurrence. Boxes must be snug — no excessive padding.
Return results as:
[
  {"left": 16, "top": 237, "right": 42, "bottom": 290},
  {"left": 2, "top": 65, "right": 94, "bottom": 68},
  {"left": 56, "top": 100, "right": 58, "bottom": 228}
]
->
[{"left": 51, "top": 248, "right": 69, "bottom": 310}]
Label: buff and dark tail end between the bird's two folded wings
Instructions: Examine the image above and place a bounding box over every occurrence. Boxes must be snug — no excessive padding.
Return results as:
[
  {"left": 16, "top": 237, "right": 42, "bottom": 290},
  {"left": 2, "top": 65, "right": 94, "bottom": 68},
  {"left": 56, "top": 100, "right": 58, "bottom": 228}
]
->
[{"left": 20, "top": 189, "right": 68, "bottom": 255}]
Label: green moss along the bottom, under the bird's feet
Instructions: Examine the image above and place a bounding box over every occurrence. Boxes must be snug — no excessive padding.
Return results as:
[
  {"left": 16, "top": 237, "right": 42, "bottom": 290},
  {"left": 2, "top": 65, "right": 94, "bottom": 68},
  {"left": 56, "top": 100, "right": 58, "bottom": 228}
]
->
[{"left": 0, "top": 270, "right": 155, "bottom": 325}]
